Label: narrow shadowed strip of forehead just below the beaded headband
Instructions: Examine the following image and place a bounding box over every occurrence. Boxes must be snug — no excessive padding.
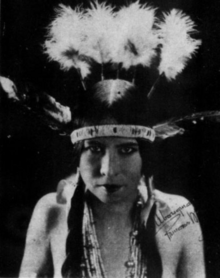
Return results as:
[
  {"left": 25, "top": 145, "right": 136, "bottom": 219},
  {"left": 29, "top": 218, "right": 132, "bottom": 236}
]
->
[{"left": 84, "top": 137, "right": 138, "bottom": 146}]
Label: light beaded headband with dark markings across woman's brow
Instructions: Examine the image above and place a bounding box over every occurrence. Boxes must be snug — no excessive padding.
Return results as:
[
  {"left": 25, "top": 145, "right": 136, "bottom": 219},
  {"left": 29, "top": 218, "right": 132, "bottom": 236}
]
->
[{"left": 70, "top": 125, "right": 155, "bottom": 144}]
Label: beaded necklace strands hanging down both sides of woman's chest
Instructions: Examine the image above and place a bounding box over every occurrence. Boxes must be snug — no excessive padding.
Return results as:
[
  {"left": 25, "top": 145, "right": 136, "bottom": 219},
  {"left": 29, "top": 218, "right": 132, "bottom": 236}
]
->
[{"left": 81, "top": 202, "right": 147, "bottom": 278}]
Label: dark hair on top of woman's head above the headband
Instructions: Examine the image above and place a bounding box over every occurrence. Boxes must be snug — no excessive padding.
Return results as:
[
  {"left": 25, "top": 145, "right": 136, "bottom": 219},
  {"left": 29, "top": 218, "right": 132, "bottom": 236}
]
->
[{"left": 71, "top": 80, "right": 152, "bottom": 129}]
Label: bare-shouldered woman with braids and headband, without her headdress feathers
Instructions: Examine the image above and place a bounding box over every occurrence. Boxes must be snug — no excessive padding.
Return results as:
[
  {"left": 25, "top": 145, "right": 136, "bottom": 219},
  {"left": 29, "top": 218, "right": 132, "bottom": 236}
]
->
[{"left": 20, "top": 80, "right": 204, "bottom": 277}]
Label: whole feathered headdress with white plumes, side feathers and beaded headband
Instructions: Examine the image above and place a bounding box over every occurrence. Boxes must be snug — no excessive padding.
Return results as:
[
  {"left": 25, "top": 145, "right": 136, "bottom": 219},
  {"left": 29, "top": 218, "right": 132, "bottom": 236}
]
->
[{"left": 0, "top": 1, "right": 220, "bottom": 142}]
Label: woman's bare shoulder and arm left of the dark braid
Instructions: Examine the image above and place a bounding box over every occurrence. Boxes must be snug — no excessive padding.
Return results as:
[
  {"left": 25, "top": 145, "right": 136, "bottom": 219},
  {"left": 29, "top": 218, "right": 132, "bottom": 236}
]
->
[{"left": 19, "top": 182, "right": 75, "bottom": 278}]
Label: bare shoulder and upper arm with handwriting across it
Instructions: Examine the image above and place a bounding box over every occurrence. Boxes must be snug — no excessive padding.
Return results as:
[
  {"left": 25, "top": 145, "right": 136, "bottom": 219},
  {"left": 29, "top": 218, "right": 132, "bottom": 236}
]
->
[{"left": 149, "top": 190, "right": 204, "bottom": 277}]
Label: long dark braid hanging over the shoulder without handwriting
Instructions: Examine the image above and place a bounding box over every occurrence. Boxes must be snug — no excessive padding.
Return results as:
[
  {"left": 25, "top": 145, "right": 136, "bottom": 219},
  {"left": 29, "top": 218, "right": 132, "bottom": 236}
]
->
[{"left": 62, "top": 180, "right": 84, "bottom": 278}]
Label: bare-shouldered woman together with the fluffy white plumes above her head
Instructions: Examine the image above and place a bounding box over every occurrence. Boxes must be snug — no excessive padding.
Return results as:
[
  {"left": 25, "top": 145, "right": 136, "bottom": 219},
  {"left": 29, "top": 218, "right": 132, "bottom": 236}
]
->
[{"left": 16, "top": 2, "right": 205, "bottom": 278}]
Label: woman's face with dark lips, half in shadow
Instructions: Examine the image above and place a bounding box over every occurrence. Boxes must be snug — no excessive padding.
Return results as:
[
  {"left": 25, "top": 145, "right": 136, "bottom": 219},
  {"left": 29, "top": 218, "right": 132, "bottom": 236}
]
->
[{"left": 79, "top": 137, "right": 142, "bottom": 203}]
